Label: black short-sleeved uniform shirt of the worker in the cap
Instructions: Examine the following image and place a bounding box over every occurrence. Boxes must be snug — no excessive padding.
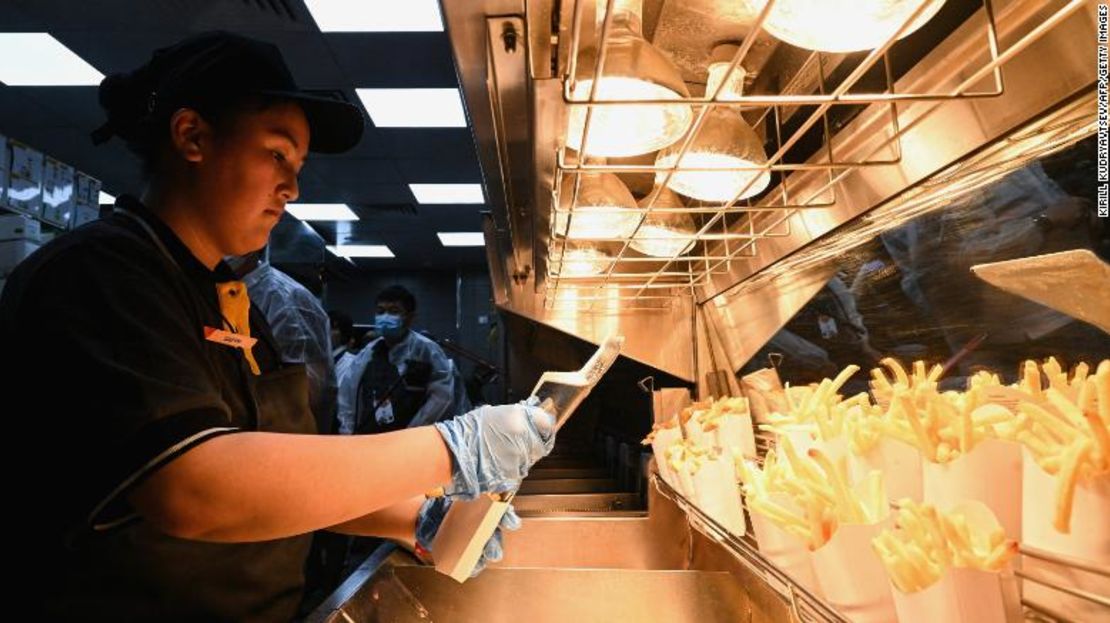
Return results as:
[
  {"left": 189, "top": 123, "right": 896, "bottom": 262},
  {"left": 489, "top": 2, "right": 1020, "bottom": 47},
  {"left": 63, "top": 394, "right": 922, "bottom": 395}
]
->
[{"left": 0, "top": 197, "right": 301, "bottom": 620}]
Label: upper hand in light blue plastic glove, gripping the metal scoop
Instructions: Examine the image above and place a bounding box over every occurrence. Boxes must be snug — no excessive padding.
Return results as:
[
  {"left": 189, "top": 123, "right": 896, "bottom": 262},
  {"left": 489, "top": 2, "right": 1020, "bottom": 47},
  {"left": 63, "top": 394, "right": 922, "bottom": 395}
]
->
[{"left": 435, "top": 403, "right": 555, "bottom": 500}]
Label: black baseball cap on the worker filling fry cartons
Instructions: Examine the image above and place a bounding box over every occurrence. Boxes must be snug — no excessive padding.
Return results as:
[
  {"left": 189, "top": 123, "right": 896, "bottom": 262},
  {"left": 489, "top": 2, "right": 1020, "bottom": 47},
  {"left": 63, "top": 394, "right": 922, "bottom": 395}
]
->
[{"left": 92, "top": 31, "right": 363, "bottom": 153}]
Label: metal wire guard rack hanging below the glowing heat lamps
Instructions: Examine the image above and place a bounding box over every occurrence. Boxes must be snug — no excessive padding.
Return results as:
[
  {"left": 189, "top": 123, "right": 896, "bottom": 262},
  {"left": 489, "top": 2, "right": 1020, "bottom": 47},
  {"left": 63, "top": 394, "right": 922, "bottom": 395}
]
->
[{"left": 544, "top": 0, "right": 1084, "bottom": 313}]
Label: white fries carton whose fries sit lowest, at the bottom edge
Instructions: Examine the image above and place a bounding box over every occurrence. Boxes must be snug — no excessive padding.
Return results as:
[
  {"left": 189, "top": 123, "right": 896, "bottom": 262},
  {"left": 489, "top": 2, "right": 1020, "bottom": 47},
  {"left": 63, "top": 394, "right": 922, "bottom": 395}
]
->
[{"left": 871, "top": 500, "right": 1021, "bottom": 623}]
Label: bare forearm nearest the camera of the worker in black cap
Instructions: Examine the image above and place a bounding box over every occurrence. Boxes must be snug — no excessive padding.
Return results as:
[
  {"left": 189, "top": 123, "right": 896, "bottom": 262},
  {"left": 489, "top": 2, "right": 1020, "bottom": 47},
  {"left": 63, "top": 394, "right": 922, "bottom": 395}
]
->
[{"left": 131, "top": 426, "right": 451, "bottom": 542}]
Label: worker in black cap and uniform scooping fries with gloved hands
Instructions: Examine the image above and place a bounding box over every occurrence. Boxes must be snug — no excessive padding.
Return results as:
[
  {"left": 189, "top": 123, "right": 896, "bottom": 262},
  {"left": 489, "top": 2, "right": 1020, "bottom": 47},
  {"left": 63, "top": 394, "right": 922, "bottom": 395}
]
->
[{"left": 0, "top": 32, "right": 554, "bottom": 622}]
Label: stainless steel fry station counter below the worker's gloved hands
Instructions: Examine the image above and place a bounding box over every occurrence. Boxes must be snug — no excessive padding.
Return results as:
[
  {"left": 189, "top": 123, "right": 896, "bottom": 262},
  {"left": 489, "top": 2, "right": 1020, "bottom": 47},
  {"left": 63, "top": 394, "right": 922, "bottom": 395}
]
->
[{"left": 307, "top": 475, "right": 808, "bottom": 623}]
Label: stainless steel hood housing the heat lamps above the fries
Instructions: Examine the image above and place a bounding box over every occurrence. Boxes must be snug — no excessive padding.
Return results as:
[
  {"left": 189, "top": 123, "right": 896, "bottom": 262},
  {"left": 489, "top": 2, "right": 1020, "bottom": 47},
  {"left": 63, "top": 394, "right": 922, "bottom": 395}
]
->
[{"left": 443, "top": 0, "right": 1096, "bottom": 381}]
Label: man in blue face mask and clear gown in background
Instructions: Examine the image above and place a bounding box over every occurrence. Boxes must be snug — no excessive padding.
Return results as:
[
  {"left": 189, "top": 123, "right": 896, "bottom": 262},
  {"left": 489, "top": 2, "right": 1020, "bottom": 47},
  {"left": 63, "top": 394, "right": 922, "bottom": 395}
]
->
[{"left": 339, "top": 285, "right": 470, "bottom": 434}]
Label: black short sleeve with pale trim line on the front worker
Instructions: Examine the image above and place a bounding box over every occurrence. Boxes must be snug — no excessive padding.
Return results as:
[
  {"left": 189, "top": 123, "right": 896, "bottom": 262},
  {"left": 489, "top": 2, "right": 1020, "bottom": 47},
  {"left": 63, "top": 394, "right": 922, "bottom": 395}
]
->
[{"left": 2, "top": 237, "right": 238, "bottom": 526}]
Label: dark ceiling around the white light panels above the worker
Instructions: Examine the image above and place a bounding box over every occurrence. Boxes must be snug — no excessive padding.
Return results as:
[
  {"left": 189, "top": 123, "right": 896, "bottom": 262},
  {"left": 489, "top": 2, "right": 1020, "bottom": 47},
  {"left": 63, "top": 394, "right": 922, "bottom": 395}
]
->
[{"left": 0, "top": 0, "right": 485, "bottom": 275}]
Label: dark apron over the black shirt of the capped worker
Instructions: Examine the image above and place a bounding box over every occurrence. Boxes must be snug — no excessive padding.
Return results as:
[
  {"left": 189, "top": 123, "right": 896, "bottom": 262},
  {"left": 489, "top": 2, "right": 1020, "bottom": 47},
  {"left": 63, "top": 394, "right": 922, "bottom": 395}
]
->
[{"left": 57, "top": 211, "right": 316, "bottom": 622}]
